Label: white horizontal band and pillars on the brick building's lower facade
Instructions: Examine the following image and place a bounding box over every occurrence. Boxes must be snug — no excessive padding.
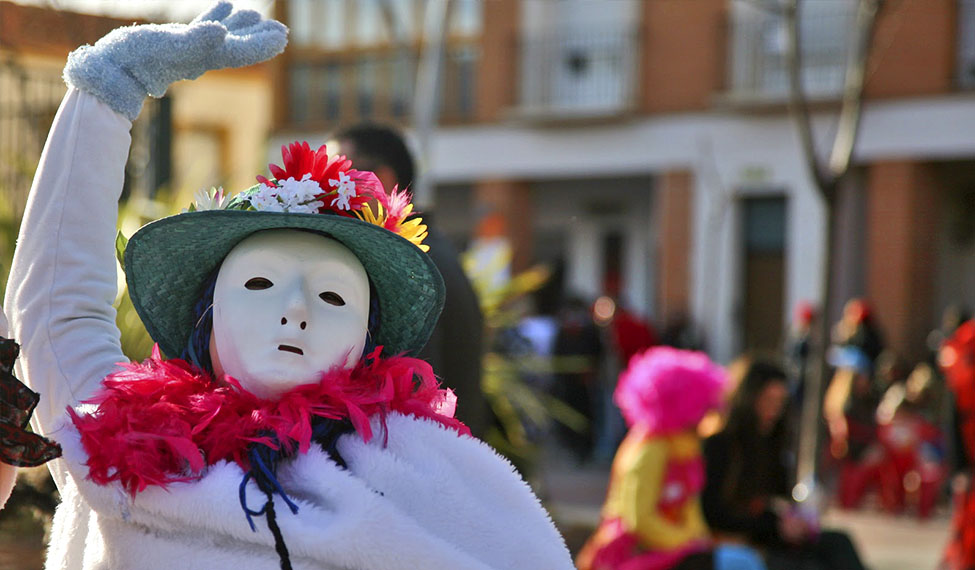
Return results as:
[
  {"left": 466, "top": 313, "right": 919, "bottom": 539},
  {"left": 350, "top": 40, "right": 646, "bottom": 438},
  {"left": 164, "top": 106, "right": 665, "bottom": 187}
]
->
[{"left": 271, "top": 94, "right": 975, "bottom": 361}]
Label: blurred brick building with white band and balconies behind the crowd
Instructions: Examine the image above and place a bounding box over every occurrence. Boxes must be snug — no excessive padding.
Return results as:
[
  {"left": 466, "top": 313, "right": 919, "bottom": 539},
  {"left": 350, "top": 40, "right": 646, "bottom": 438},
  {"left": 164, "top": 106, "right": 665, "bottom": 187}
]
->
[{"left": 266, "top": 0, "right": 975, "bottom": 359}]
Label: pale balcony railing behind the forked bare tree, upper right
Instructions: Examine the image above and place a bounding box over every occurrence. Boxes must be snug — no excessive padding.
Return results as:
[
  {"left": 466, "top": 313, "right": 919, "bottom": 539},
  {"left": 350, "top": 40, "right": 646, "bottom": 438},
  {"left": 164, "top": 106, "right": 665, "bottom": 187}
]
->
[{"left": 728, "top": 2, "right": 856, "bottom": 101}]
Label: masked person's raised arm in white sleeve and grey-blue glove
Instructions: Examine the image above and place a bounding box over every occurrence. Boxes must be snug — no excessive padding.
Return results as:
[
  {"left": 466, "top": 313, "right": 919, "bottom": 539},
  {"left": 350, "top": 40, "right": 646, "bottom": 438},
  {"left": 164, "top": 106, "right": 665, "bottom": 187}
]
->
[{"left": 5, "top": 2, "right": 287, "bottom": 444}]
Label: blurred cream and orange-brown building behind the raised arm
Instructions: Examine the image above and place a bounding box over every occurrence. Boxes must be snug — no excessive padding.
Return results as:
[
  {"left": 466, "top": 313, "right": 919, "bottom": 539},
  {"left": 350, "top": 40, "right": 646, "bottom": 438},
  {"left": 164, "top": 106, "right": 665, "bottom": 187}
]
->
[{"left": 0, "top": 1, "right": 272, "bottom": 217}]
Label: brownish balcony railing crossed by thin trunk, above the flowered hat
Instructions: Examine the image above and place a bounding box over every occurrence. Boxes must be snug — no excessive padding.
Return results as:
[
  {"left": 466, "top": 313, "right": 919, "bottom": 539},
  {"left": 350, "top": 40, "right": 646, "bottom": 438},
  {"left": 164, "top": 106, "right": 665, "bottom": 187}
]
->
[{"left": 284, "top": 43, "right": 480, "bottom": 128}]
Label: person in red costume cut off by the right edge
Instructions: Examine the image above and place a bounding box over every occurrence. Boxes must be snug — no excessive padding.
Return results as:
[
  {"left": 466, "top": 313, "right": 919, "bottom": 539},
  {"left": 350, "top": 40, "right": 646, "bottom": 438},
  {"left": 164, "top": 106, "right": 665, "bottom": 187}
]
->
[{"left": 938, "top": 321, "right": 975, "bottom": 570}]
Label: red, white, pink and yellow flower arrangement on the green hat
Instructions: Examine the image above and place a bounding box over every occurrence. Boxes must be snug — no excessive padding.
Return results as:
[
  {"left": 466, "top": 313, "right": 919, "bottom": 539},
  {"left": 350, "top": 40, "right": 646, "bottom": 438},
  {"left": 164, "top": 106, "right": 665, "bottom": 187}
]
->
[{"left": 200, "top": 141, "right": 430, "bottom": 251}]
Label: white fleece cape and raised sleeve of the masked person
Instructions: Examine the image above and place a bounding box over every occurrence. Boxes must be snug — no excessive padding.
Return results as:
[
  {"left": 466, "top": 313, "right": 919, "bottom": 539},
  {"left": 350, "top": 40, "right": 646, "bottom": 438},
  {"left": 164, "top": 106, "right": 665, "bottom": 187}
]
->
[{"left": 4, "top": 88, "right": 572, "bottom": 570}]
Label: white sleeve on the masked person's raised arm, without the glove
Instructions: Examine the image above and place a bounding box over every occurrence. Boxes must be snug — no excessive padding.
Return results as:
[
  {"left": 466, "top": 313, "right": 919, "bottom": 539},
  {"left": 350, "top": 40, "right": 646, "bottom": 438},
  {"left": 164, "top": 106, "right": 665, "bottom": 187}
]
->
[{"left": 4, "top": 88, "right": 132, "bottom": 439}]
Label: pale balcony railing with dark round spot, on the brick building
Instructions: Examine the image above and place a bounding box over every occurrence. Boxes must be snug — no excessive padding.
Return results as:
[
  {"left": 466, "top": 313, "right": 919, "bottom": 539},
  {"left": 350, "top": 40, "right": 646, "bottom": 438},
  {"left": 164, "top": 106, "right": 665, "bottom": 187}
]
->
[{"left": 517, "top": 28, "right": 640, "bottom": 118}]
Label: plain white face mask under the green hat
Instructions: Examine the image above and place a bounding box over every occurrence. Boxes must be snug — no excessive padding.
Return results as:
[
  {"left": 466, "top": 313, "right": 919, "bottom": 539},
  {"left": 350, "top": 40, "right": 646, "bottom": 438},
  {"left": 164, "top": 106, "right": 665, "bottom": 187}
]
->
[{"left": 210, "top": 230, "right": 369, "bottom": 398}]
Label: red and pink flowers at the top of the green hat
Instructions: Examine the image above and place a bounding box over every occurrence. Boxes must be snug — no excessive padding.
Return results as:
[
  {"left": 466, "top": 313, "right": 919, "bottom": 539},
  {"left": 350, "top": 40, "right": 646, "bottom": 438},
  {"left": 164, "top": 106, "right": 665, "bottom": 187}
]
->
[{"left": 257, "top": 141, "right": 385, "bottom": 216}]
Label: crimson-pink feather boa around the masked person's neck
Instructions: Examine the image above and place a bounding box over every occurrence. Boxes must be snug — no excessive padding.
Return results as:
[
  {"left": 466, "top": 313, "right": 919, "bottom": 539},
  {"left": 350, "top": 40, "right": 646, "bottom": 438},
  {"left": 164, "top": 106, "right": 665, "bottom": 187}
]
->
[{"left": 68, "top": 346, "right": 470, "bottom": 495}]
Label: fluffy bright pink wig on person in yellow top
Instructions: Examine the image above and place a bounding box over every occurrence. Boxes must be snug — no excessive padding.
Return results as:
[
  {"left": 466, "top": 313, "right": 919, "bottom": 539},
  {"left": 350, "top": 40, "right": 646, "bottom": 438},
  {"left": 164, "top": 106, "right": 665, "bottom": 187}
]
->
[{"left": 613, "top": 346, "right": 725, "bottom": 435}]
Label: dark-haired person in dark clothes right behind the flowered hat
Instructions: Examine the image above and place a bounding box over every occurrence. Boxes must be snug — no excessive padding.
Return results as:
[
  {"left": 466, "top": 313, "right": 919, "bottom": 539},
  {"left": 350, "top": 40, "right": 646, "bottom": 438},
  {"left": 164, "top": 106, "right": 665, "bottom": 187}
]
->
[{"left": 328, "top": 123, "right": 489, "bottom": 438}]
